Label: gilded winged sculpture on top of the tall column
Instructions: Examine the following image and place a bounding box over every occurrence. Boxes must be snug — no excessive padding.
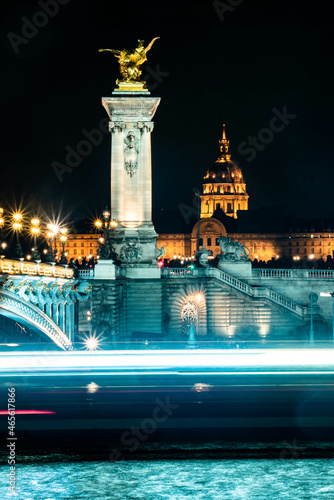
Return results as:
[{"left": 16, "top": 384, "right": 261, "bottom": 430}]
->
[{"left": 99, "top": 37, "right": 160, "bottom": 91}]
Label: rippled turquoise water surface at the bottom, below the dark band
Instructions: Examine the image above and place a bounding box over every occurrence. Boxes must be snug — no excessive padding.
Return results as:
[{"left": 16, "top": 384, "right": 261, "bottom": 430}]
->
[{"left": 0, "top": 449, "right": 334, "bottom": 500}]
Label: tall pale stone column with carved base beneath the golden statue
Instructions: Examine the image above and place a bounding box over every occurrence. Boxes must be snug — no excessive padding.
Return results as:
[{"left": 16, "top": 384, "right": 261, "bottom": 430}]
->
[{"left": 102, "top": 92, "right": 161, "bottom": 278}]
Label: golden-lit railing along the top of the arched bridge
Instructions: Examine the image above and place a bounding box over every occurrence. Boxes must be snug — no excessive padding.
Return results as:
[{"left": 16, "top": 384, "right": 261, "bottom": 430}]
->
[{"left": 0, "top": 259, "right": 73, "bottom": 278}]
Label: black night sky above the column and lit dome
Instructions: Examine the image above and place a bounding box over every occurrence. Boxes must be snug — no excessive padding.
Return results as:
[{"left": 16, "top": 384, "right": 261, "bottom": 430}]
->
[{"left": 0, "top": 0, "right": 334, "bottom": 223}]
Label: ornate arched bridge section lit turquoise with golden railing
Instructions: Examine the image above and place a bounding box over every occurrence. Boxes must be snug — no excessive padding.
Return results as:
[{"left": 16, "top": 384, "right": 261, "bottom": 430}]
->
[{"left": 0, "top": 259, "right": 90, "bottom": 350}]
